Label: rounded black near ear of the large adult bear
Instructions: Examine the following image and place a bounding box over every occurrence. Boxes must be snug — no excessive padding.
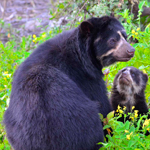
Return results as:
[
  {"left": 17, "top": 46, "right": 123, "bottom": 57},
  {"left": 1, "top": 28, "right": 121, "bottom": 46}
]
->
[{"left": 80, "top": 21, "right": 93, "bottom": 35}]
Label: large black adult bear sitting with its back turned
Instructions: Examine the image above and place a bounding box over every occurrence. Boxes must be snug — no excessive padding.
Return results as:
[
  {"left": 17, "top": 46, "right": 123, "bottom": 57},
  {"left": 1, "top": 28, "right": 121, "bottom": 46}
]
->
[{"left": 4, "top": 16, "right": 135, "bottom": 150}]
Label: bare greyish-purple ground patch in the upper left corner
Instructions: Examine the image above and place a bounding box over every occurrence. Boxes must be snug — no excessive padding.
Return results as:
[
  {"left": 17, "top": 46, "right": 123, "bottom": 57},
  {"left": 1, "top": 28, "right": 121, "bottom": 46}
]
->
[{"left": 0, "top": 0, "right": 54, "bottom": 42}]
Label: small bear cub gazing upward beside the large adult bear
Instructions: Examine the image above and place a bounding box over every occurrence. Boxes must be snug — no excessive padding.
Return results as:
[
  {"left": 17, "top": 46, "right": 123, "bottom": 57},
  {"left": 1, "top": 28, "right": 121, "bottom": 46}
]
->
[{"left": 111, "top": 67, "right": 148, "bottom": 122}]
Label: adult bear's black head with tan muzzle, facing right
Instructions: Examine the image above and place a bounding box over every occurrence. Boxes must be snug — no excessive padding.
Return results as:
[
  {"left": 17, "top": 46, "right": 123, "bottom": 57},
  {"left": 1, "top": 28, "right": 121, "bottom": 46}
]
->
[{"left": 80, "top": 16, "right": 135, "bottom": 66}]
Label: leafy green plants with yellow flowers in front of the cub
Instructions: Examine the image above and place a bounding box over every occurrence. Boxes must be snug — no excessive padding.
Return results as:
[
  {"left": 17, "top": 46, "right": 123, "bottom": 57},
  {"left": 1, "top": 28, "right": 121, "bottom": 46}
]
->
[{"left": 98, "top": 108, "right": 150, "bottom": 150}]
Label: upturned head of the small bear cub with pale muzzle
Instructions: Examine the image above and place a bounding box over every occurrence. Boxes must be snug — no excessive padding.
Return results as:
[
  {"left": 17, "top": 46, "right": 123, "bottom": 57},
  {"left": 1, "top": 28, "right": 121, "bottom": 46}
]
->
[{"left": 113, "top": 67, "right": 148, "bottom": 95}]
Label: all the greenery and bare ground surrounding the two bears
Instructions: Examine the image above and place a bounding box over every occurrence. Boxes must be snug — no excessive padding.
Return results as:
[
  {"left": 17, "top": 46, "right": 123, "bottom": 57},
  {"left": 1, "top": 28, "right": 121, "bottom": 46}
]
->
[{"left": 0, "top": 0, "right": 150, "bottom": 150}]
